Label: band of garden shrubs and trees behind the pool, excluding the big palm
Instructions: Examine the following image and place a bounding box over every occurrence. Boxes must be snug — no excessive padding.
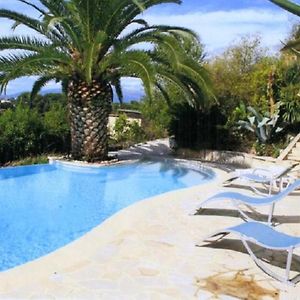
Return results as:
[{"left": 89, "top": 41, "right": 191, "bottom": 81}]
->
[{"left": 0, "top": 33, "right": 300, "bottom": 164}]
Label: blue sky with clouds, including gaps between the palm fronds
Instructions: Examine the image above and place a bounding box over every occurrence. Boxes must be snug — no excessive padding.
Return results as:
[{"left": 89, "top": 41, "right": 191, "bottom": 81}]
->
[{"left": 0, "top": 0, "right": 299, "bottom": 94}]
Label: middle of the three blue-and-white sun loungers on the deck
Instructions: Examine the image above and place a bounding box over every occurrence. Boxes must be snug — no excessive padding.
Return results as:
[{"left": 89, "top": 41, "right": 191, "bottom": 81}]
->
[{"left": 199, "top": 179, "right": 300, "bottom": 224}]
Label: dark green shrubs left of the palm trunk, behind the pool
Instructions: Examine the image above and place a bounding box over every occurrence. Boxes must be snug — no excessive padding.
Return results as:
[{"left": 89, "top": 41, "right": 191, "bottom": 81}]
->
[{"left": 0, "top": 101, "right": 70, "bottom": 164}]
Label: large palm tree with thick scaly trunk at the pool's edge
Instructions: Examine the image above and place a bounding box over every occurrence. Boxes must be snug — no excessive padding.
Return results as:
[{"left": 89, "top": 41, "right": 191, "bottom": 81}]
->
[{"left": 0, "top": 0, "right": 210, "bottom": 161}]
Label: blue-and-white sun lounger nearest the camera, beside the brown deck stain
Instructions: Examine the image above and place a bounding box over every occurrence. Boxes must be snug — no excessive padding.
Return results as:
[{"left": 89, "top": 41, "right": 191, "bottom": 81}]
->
[{"left": 205, "top": 222, "right": 300, "bottom": 285}]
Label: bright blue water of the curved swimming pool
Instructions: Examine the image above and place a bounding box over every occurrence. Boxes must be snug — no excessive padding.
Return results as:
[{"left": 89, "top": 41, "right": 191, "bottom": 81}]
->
[{"left": 0, "top": 161, "right": 214, "bottom": 271}]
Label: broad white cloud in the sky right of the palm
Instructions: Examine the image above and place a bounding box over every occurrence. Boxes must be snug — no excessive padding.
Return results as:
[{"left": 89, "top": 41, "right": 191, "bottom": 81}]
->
[{"left": 144, "top": 9, "right": 289, "bottom": 54}]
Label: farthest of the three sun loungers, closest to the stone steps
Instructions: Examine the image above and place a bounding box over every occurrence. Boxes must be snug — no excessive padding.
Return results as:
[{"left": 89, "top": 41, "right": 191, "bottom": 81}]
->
[{"left": 223, "top": 163, "right": 299, "bottom": 195}]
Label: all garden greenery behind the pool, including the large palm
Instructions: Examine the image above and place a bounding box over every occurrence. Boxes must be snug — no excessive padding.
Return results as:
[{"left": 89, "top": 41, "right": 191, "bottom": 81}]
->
[{"left": 0, "top": 0, "right": 300, "bottom": 165}]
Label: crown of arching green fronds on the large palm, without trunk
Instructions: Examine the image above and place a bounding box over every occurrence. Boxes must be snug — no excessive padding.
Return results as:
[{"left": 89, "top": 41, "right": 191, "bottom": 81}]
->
[{"left": 0, "top": 0, "right": 212, "bottom": 105}]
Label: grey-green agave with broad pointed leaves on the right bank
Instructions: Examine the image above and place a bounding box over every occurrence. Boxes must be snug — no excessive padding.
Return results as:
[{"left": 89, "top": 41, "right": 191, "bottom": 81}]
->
[{"left": 237, "top": 106, "right": 283, "bottom": 144}]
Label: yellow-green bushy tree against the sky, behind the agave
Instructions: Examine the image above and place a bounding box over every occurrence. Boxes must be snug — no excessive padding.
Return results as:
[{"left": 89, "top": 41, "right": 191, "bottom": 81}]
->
[{"left": 209, "top": 36, "right": 273, "bottom": 113}]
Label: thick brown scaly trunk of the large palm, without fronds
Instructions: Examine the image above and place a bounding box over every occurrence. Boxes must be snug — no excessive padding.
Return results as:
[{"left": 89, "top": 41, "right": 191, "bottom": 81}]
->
[{"left": 68, "top": 80, "right": 113, "bottom": 161}]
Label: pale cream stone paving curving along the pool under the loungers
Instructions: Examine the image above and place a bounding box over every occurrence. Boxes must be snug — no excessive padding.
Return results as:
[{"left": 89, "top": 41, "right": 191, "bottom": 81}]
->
[{"left": 0, "top": 163, "right": 300, "bottom": 300}]
